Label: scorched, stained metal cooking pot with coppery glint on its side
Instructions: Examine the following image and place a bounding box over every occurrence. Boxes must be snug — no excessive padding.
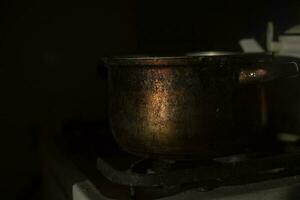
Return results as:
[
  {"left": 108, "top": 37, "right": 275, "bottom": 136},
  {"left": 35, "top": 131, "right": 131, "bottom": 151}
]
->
[{"left": 105, "top": 54, "right": 298, "bottom": 159}]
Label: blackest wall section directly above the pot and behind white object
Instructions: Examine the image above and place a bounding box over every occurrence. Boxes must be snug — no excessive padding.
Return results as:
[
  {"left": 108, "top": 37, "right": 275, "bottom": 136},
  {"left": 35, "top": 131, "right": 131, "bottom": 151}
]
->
[{"left": 137, "top": 0, "right": 300, "bottom": 54}]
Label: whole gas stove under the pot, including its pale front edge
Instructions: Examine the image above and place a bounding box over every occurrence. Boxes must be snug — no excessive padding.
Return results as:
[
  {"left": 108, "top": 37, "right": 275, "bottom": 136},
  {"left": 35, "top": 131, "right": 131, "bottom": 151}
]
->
[{"left": 41, "top": 121, "right": 300, "bottom": 200}]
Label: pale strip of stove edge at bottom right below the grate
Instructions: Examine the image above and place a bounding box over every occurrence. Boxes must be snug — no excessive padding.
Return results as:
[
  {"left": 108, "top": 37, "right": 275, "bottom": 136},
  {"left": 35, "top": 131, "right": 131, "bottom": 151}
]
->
[{"left": 159, "top": 180, "right": 300, "bottom": 200}]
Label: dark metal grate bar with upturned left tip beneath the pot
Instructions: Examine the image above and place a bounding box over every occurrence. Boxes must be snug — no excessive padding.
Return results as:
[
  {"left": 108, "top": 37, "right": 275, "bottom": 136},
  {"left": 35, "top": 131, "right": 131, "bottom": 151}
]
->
[{"left": 97, "top": 154, "right": 300, "bottom": 190}]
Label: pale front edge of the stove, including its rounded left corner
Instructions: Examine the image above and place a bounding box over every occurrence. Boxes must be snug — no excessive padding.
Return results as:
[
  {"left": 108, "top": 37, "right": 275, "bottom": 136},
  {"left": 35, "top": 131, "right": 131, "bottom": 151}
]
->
[{"left": 73, "top": 172, "right": 300, "bottom": 200}]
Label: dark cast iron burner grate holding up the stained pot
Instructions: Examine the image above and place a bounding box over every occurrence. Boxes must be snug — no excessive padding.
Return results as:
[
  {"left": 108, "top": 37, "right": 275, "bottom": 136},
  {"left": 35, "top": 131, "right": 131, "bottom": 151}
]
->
[{"left": 97, "top": 153, "right": 300, "bottom": 198}]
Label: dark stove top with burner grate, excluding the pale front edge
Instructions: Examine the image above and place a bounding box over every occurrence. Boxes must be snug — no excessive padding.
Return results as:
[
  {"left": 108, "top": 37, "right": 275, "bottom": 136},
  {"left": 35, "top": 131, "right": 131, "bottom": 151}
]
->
[{"left": 57, "top": 121, "right": 300, "bottom": 199}]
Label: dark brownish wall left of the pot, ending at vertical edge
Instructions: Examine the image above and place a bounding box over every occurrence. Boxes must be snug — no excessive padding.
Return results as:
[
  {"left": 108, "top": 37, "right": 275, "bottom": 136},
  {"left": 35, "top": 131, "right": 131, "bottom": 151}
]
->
[{"left": 0, "top": 0, "right": 136, "bottom": 199}]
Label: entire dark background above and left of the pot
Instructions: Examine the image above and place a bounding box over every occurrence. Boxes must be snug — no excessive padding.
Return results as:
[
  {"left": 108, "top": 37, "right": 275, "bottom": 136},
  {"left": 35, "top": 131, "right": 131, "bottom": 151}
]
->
[{"left": 0, "top": 0, "right": 300, "bottom": 199}]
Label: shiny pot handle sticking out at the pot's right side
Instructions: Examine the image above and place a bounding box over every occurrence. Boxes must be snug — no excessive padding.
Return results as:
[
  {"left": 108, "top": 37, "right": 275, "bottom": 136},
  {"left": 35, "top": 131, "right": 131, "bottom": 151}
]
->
[{"left": 238, "top": 62, "right": 299, "bottom": 84}]
